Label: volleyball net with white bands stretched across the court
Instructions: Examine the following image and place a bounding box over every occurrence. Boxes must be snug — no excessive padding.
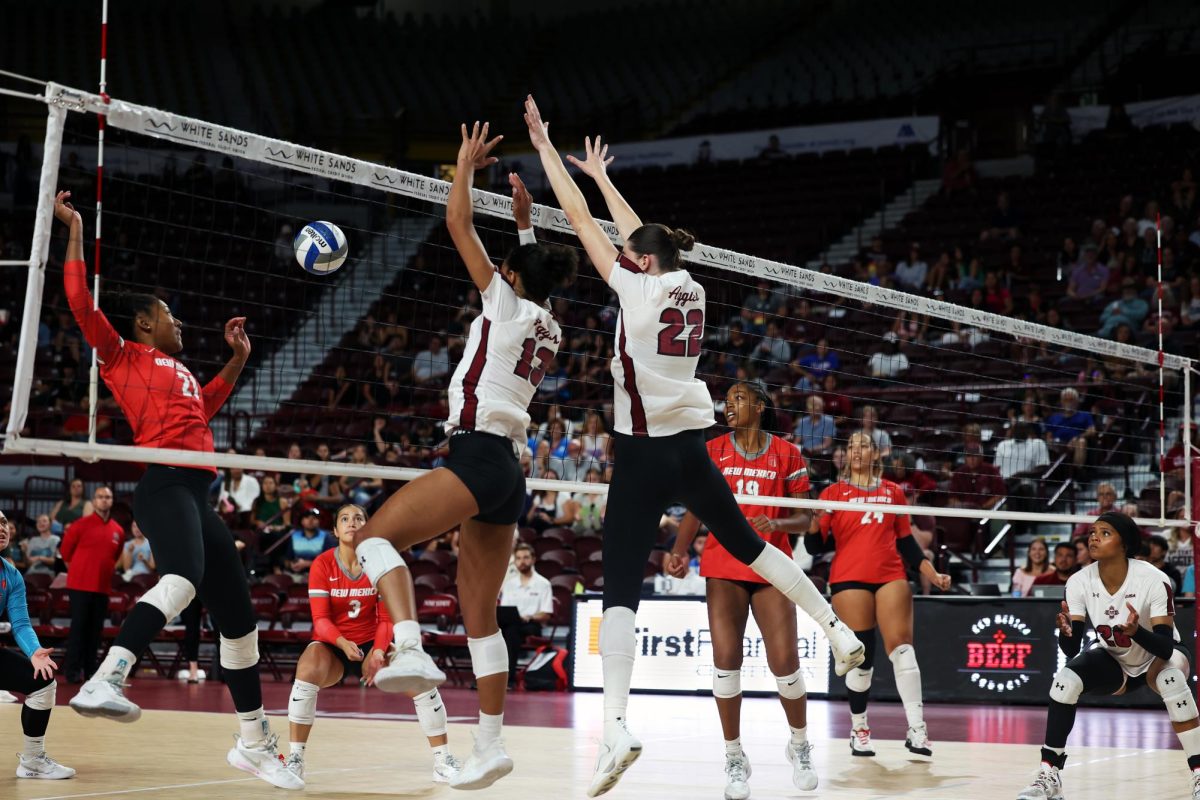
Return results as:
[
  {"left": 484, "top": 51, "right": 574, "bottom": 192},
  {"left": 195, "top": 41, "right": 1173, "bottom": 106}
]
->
[{"left": 4, "top": 84, "right": 1194, "bottom": 537}]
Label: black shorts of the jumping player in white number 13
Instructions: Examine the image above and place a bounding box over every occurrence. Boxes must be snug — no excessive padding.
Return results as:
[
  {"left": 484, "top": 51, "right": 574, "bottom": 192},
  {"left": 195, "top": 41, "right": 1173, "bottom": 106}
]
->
[{"left": 442, "top": 431, "right": 526, "bottom": 525}]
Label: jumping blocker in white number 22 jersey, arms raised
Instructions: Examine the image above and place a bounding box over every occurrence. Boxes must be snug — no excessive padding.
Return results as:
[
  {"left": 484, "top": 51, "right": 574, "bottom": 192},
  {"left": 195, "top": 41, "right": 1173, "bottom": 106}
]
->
[{"left": 526, "top": 97, "right": 864, "bottom": 798}]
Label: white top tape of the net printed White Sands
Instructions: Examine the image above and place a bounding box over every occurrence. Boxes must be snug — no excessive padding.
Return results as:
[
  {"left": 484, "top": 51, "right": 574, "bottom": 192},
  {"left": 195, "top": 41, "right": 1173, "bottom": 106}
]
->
[{"left": 32, "top": 84, "right": 1189, "bottom": 369}]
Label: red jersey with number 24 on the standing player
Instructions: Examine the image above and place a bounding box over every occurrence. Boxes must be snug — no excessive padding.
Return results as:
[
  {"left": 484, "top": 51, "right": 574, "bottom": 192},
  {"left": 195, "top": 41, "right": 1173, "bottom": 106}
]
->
[{"left": 820, "top": 481, "right": 912, "bottom": 583}]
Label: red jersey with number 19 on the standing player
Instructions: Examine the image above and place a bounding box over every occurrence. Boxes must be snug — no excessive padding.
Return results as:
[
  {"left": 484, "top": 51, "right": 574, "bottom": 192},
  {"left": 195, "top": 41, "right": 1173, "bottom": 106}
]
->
[{"left": 700, "top": 433, "right": 809, "bottom": 583}]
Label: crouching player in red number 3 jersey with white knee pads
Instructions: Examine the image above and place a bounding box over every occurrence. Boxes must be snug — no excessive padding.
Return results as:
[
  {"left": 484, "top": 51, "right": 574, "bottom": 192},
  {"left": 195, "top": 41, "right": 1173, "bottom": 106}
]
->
[{"left": 287, "top": 504, "right": 461, "bottom": 783}]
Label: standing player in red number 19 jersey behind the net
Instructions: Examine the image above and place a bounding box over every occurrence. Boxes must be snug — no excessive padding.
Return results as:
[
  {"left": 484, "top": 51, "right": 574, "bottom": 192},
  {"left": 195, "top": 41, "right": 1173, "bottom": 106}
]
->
[{"left": 667, "top": 384, "right": 817, "bottom": 800}]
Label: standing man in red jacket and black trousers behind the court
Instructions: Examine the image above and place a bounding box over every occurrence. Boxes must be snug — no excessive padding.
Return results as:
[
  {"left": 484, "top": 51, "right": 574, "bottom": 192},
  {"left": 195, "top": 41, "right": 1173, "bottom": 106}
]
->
[{"left": 62, "top": 485, "right": 125, "bottom": 684}]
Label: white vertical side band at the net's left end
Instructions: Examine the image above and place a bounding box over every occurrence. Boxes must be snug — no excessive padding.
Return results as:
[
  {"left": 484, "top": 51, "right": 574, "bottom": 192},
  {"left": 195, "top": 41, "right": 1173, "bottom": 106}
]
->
[{"left": 7, "top": 104, "right": 67, "bottom": 443}]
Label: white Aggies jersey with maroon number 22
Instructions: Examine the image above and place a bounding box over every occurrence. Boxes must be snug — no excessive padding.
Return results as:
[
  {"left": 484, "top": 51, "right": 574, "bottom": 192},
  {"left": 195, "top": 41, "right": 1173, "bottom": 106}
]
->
[{"left": 608, "top": 254, "right": 716, "bottom": 437}]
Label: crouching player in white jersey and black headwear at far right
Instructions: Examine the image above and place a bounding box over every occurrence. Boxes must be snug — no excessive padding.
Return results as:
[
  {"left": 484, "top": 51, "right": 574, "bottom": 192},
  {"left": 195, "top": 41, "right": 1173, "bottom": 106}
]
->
[{"left": 1018, "top": 511, "right": 1200, "bottom": 800}]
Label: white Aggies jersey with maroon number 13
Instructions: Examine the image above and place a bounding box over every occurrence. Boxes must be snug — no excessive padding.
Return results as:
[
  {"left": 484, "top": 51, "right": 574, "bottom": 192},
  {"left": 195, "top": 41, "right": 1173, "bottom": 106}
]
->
[{"left": 446, "top": 272, "right": 563, "bottom": 447}]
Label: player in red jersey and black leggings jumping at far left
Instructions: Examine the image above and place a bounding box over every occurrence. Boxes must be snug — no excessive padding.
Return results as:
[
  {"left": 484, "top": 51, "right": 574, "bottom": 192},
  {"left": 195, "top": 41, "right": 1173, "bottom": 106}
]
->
[{"left": 54, "top": 192, "right": 304, "bottom": 789}]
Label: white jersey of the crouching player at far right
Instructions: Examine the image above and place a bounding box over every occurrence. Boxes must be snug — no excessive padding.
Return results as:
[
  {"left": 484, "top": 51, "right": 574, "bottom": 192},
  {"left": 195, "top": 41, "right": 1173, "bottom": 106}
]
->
[{"left": 1067, "top": 559, "right": 1180, "bottom": 676}]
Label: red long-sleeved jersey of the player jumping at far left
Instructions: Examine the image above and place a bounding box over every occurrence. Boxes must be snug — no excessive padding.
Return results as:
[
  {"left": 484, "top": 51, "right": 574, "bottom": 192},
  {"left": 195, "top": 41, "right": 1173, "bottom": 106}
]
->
[{"left": 62, "top": 261, "right": 233, "bottom": 473}]
